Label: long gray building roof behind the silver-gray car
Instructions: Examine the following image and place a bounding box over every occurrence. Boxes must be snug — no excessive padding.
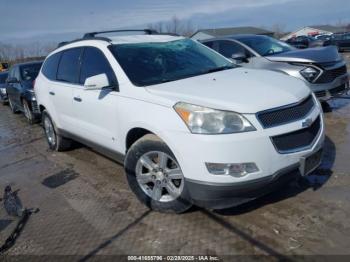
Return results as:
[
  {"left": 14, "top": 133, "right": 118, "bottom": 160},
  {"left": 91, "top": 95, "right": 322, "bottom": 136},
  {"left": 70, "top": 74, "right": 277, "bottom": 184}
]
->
[{"left": 193, "top": 26, "right": 274, "bottom": 36}]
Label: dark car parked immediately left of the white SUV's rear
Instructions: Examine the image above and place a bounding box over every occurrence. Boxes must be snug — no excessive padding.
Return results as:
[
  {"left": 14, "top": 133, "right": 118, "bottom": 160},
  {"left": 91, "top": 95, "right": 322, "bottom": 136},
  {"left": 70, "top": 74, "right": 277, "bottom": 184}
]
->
[{"left": 6, "top": 62, "right": 42, "bottom": 124}]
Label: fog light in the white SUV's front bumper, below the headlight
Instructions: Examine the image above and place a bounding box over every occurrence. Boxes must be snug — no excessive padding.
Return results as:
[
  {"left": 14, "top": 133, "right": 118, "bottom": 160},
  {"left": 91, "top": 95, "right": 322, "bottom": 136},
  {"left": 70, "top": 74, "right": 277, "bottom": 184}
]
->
[{"left": 205, "top": 163, "right": 259, "bottom": 177}]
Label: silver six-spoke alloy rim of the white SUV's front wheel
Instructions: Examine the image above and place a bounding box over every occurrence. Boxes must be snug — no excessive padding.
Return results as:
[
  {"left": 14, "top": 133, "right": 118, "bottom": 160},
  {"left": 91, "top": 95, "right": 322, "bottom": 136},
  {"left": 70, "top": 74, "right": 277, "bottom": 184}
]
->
[{"left": 136, "top": 151, "right": 184, "bottom": 202}]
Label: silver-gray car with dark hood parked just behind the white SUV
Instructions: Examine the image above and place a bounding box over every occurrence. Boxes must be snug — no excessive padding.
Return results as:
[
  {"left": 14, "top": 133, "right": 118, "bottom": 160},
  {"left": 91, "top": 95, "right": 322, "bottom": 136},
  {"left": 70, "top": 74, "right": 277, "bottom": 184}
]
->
[{"left": 203, "top": 35, "right": 349, "bottom": 101}]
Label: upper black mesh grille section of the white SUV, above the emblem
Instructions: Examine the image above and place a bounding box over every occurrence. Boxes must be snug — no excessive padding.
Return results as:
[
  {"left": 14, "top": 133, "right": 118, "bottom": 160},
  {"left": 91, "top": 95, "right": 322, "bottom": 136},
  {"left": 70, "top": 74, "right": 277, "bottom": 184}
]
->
[{"left": 257, "top": 95, "right": 314, "bottom": 128}]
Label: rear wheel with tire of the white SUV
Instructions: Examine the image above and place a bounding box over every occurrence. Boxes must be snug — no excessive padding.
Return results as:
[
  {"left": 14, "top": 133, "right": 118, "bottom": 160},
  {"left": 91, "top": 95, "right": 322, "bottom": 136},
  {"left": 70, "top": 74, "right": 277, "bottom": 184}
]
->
[{"left": 42, "top": 110, "right": 72, "bottom": 152}]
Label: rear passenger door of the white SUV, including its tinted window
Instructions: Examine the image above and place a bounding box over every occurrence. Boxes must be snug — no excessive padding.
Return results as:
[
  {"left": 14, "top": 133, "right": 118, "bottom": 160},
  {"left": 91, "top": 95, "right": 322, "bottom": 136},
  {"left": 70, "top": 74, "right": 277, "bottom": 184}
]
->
[{"left": 53, "top": 48, "right": 83, "bottom": 131}]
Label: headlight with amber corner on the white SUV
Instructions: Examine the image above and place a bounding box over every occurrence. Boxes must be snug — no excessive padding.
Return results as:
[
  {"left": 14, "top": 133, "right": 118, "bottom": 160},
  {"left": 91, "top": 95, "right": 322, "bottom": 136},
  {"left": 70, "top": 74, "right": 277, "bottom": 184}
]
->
[{"left": 174, "top": 102, "right": 256, "bottom": 134}]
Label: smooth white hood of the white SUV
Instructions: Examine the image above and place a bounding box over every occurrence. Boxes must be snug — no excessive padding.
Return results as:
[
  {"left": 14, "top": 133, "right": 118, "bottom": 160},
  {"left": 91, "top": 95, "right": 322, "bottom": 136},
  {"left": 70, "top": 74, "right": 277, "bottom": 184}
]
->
[{"left": 146, "top": 68, "right": 310, "bottom": 113}]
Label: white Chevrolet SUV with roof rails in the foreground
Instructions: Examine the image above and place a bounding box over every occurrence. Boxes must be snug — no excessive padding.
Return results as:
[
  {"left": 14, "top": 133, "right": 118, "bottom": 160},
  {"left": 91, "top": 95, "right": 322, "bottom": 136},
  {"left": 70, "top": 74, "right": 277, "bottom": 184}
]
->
[{"left": 35, "top": 31, "right": 324, "bottom": 213}]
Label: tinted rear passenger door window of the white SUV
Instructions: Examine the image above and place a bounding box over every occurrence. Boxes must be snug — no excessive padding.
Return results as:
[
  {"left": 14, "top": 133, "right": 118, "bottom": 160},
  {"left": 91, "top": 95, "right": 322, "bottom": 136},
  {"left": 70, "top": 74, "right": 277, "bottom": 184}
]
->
[{"left": 57, "top": 48, "right": 82, "bottom": 83}]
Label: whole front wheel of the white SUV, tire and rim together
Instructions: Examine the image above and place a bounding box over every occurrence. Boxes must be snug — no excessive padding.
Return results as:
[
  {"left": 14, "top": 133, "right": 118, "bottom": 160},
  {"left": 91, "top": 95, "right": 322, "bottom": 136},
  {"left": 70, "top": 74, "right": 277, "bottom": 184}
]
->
[{"left": 124, "top": 134, "right": 192, "bottom": 213}]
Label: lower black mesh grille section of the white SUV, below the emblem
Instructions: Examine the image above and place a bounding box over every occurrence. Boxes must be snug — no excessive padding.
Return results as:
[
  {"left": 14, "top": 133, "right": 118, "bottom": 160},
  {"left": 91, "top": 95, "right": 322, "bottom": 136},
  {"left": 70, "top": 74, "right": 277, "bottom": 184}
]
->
[{"left": 271, "top": 117, "right": 321, "bottom": 154}]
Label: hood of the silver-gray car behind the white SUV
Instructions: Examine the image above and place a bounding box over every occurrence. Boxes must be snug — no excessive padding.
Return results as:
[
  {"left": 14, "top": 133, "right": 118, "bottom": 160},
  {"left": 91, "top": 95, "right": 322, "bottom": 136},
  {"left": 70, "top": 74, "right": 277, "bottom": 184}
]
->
[{"left": 265, "top": 46, "right": 342, "bottom": 63}]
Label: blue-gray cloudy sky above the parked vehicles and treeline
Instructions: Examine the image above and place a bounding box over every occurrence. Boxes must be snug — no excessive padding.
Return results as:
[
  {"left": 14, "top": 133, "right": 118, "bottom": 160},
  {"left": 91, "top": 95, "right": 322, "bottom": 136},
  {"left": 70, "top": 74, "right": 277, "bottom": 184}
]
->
[{"left": 0, "top": 0, "right": 350, "bottom": 42}]
